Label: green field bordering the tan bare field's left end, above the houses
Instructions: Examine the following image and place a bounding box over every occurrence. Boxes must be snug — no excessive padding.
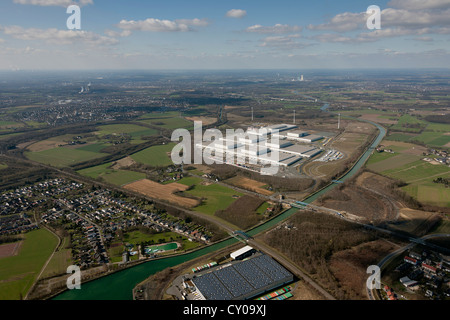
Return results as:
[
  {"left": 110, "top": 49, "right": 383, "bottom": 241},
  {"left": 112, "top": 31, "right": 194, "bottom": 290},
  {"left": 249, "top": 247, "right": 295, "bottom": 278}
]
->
[{"left": 78, "top": 162, "right": 146, "bottom": 186}]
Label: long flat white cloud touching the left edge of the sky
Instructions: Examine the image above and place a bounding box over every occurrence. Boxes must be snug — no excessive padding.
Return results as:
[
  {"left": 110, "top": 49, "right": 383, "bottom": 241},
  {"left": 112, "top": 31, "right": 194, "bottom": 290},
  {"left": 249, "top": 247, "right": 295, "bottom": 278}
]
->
[{"left": 0, "top": 26, "right": 118, "bottom": 46}]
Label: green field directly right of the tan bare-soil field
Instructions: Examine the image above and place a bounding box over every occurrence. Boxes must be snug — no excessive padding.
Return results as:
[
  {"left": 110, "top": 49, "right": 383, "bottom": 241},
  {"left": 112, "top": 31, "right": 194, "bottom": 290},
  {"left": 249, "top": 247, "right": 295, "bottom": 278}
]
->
[{"left": 187, "top": 184, "right": 244, "bottom": 215}]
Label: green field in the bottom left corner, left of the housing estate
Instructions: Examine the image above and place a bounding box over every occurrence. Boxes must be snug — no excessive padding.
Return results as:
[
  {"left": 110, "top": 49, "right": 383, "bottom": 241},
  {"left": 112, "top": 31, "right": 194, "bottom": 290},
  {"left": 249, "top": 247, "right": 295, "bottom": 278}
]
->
[{"left": 0, "top": 229, "right": 58, "bottom": 300}]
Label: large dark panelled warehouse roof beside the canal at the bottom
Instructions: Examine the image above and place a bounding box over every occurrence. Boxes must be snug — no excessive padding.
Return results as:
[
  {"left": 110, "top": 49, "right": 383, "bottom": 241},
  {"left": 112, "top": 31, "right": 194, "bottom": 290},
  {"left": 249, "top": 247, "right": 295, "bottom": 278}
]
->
[{"left": 192, "top": 255, "right": 292, "bottom": 300}]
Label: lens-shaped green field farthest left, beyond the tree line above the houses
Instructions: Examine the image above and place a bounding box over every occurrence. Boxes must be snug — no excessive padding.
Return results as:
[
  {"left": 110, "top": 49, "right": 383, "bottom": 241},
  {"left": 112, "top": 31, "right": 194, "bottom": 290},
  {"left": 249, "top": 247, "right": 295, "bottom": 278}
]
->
[{"left": 25, "top": 147, "right": 107, "bottom": 167}]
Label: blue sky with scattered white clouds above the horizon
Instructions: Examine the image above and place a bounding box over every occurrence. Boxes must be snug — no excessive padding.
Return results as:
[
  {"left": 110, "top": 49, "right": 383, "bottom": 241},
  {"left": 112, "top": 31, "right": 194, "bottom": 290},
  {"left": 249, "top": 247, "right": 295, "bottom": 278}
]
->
[{"left": 0, "top": 0, "right": 450, "bottom": 70}]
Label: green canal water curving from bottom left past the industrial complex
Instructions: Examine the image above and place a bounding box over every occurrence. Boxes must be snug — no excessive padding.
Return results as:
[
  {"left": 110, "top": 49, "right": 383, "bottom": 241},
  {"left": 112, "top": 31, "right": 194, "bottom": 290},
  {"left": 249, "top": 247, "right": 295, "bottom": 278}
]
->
[{"left": 53, "top": 117, "right": 386, "bottom": 300}]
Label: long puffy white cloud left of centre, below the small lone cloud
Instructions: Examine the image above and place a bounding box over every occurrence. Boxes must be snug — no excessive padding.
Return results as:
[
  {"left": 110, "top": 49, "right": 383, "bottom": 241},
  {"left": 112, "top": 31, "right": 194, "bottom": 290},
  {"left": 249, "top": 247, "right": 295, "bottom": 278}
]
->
[{"left": 117, "top": 18, "right": 209, "bottom": 32}]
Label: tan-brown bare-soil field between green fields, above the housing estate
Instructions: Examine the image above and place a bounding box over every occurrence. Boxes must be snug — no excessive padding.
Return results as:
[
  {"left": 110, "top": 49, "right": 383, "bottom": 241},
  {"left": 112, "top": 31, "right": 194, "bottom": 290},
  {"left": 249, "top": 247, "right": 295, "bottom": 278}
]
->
[{"left": 124, "top": 179, "right": 200, "bottom": 208}]
